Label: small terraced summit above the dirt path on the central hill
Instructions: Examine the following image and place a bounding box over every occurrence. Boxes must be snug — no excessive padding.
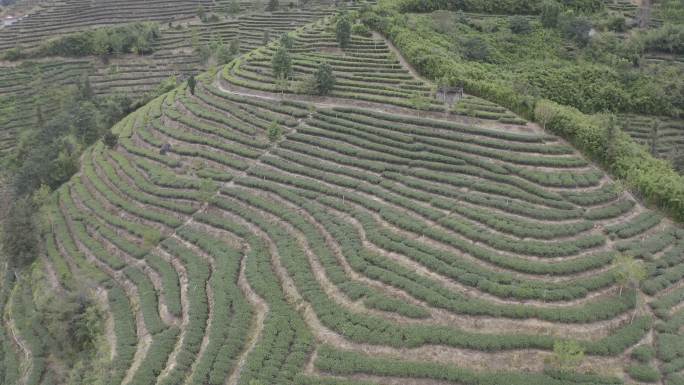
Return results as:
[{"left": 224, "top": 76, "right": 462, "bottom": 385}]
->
[{"left": 223, "top": 20, "right": 444, "bottom": 111}]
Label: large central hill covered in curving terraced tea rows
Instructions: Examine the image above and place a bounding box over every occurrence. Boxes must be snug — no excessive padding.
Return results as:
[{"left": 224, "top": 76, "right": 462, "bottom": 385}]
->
[{"left": 6, "top": 10, "right": 684, "bottom": 385}]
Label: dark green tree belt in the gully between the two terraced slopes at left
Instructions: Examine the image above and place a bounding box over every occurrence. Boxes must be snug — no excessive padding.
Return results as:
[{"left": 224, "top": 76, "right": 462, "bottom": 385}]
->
[{"left": 2, "top": 77, "right": 132, "bottom": 269}]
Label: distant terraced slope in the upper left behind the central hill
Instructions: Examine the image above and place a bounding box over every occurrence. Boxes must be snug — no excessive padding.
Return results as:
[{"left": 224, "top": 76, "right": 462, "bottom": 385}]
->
[{"left": 0, "top": 1, "right": 340, "bottom": 165}]
